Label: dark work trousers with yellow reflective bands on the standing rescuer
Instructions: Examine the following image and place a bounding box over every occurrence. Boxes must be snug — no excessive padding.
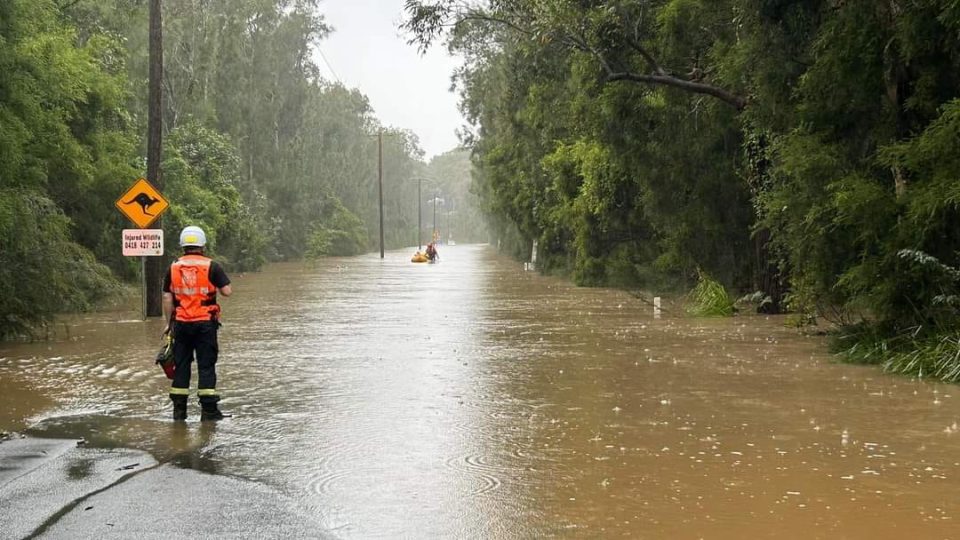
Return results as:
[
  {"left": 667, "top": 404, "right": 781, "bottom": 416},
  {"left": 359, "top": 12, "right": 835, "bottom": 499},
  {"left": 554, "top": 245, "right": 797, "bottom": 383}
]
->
[{"left": 170, "top": 321, "right": 220, "bottom": 405}]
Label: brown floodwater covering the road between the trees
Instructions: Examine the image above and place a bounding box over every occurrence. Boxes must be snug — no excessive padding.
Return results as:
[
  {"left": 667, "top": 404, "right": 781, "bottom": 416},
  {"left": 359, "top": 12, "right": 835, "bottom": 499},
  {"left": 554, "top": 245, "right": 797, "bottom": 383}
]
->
[{"left": 0, "top": 246, "right": 960, "bottom": 539}]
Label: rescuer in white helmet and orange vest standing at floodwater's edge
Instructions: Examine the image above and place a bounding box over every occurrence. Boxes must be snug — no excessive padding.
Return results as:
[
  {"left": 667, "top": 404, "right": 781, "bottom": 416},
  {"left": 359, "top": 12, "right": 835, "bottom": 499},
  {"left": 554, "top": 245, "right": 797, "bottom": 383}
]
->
[{"left": 163, "top": 226, "right": 233, "bottom": 421}]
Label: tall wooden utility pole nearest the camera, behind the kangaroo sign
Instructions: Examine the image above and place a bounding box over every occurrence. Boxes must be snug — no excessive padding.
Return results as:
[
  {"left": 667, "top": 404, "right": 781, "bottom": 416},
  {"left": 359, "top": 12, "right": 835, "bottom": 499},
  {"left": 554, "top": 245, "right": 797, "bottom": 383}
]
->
[{"left": 144, "top": 0, "right": 163, "bottom": 317}]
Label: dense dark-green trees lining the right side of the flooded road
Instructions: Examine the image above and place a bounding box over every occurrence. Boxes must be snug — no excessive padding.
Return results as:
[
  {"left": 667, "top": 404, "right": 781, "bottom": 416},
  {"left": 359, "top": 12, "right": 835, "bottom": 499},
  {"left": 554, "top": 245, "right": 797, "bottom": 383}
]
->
[{"left": 405, "top": 0, "right": 960, "bottom": 380}]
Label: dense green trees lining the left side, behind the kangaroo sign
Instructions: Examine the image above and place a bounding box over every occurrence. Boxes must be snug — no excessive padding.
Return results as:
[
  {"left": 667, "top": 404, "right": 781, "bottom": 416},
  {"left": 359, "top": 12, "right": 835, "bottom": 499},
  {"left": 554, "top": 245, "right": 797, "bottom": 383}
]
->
[{"left": 0, "top": 0, "right": 480, "bottom": 338}]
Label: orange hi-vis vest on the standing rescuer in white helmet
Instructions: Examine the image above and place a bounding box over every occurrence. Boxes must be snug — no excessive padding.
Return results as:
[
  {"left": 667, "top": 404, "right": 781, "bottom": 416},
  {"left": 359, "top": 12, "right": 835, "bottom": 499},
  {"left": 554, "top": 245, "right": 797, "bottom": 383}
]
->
[{"left": 170, "top": 254, "right": 220, "bottom": 322}]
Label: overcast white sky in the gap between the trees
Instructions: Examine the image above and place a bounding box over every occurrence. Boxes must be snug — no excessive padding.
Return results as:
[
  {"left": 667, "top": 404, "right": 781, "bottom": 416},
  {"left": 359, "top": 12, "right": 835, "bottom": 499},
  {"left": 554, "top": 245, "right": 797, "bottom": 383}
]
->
[{"left": 316, "top": 0, "right": 464, "bottom": 161}]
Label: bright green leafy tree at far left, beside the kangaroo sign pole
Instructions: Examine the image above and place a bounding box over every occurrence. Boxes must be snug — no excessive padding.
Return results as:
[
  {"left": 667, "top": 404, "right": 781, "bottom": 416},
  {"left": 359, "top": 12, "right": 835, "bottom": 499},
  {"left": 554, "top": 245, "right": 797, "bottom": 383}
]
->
[{"left": 0, "top": 0, "right": 129, "bottom": 337}]
